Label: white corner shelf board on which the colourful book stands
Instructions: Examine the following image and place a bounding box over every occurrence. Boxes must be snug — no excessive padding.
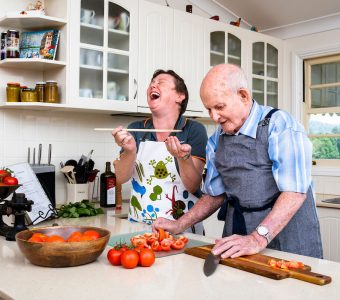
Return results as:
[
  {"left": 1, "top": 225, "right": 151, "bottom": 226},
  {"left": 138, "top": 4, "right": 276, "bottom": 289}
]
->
[{"left": 0, "top": 58, "right": 66, "bottom": 71}]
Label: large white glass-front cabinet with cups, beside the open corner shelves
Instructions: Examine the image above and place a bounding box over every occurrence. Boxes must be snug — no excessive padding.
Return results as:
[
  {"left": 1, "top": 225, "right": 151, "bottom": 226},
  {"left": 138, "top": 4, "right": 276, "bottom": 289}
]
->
[{"left": 70, "top": 0, "right": 138, "bottom": 111}]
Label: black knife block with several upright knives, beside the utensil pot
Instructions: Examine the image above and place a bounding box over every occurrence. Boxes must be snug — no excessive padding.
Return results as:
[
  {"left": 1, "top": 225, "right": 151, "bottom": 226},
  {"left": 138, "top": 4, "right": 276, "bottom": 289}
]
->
[{"left": 28, "top": 144, "right": 56, "bottom": 208}]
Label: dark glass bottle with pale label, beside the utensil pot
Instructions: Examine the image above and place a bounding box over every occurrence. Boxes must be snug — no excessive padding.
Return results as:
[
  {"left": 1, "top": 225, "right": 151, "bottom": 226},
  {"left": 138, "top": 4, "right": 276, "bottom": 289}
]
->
[{"left": 100, "top": 162, "right": 116, "bottom": 207}]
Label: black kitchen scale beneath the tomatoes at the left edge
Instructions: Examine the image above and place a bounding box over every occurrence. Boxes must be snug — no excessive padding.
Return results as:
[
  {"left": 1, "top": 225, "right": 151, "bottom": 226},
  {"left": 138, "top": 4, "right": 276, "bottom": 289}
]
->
[{"left": 0, "top": 185, "right": 33, "bottom": 241}]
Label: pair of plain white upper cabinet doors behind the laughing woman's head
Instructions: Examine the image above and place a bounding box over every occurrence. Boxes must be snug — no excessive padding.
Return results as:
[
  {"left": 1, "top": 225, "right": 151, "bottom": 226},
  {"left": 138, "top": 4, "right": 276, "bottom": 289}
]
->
[{"left": 138, "top": 1, "right": 204, "bottom": 116}]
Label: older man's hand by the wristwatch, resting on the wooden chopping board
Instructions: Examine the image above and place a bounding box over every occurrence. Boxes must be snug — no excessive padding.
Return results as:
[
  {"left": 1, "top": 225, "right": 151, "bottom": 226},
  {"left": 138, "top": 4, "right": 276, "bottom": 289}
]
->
[{"left": 212, "top": 233, "right": 267, "bottom": 258}]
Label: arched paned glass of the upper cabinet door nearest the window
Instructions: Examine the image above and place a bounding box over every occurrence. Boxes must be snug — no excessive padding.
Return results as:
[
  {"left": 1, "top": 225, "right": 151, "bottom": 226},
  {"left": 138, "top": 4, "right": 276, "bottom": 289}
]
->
[{"left": 251, "top": 42, "right": 279, "bottom": 107}]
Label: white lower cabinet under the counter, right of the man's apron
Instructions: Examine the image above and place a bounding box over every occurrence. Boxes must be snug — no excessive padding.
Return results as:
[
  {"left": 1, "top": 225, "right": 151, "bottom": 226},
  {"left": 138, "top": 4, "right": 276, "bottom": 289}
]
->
[{"left": 317, "top": 207, "right": 340, "bottom": 262}]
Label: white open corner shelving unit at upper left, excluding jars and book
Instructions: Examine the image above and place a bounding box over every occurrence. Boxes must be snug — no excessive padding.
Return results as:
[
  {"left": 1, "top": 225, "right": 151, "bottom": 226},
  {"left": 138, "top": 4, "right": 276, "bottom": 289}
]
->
[{"left": 0, "top": 0, "right": 69, "bottom": 109}]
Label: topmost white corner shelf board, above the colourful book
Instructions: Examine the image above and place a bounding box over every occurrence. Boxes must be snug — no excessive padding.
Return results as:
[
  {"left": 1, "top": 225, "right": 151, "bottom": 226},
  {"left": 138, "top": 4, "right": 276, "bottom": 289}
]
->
[{"left": 0, "top": 14, "right": 67, "bottom": 29}]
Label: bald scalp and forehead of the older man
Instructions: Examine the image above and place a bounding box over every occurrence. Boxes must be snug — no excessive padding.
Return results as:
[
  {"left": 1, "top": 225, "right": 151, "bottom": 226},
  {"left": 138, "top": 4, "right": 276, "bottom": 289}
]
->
[{"left": 200, "top": 64, "right": 248, "bottom": 101}]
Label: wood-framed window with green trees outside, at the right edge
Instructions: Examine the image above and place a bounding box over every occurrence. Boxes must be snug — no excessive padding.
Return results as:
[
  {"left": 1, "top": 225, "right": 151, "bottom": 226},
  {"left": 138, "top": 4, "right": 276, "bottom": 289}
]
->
[{"left": 305, "top": 55, "right": 340, "bottom": 166}]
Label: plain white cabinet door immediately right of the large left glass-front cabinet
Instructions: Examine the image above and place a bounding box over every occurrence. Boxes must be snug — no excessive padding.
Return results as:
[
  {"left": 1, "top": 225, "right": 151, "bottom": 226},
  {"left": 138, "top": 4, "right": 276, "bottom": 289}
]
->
[{"left": 138, "top": 1, "right": 174, "bottom": 113}]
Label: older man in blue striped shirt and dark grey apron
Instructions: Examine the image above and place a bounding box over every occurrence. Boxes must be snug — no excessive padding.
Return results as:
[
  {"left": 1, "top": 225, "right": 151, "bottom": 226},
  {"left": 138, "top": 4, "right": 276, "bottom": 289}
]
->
[{"left": 153, "top": 64, "right": 322, "bottom": 258}]
